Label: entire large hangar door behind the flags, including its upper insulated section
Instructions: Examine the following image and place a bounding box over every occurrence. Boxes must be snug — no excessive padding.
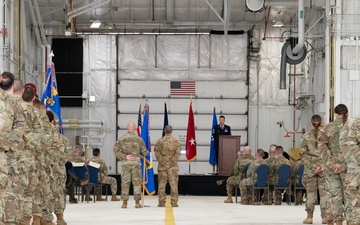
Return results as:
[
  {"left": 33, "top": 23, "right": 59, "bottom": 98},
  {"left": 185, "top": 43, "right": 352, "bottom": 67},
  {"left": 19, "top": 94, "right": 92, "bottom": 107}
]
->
[{"left": 117, "top": 35, "right": 249, "bottom": 174}]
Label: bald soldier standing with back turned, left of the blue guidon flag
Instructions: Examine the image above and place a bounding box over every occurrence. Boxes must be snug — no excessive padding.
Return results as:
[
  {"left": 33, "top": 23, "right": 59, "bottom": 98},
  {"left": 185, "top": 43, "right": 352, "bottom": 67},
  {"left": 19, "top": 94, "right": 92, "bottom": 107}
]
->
[{"left": 113, "top": 122, "right": 148, "bottom": 208}]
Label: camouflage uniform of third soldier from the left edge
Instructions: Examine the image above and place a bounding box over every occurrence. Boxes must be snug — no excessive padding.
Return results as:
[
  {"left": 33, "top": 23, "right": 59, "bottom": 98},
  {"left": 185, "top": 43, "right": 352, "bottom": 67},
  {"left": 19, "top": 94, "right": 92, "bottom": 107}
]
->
[{"left": 17, "top": 98, "right": 41, "bottom": 221}]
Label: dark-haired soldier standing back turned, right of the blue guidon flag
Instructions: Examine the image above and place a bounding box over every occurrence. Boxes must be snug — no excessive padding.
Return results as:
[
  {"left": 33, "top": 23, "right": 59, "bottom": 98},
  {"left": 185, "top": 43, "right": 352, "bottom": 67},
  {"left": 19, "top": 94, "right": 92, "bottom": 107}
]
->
[{"left": 154, "top": 125, "right": 181, "bottom": 207}]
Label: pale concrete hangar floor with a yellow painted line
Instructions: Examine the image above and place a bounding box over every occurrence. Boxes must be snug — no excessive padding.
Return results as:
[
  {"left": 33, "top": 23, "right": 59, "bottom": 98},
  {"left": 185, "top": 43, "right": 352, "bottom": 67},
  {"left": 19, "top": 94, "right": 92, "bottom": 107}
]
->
[{"left": 59, "top": 196, "right": 330, "bottom": 225}]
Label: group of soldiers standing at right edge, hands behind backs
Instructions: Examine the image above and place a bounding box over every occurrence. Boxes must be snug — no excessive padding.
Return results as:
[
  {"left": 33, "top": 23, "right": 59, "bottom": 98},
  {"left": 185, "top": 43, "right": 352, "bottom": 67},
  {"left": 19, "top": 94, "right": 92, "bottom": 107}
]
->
[{"left": 301, "top": 104, "right": 360, "bottom": 225}]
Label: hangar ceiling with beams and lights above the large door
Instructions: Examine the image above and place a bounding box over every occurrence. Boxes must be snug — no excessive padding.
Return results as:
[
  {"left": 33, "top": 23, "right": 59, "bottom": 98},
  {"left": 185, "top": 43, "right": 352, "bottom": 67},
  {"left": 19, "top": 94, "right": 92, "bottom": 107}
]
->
[{"left": 32, "top": 0, "right": 323, "bottom": 32}]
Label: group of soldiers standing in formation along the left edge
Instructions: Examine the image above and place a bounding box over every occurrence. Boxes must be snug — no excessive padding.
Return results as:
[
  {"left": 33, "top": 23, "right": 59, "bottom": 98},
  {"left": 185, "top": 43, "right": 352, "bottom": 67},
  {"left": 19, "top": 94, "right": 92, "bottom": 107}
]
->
[{"left": 0, "top": 72, "right": 73, "bottom": 225}]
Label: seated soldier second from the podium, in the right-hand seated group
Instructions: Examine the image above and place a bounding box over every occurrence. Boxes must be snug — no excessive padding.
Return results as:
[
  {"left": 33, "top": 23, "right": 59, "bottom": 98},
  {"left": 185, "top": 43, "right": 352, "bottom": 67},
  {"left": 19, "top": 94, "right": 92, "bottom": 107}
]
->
[{"left": 240, "top": 149, "right": 266, "bottom": 205}]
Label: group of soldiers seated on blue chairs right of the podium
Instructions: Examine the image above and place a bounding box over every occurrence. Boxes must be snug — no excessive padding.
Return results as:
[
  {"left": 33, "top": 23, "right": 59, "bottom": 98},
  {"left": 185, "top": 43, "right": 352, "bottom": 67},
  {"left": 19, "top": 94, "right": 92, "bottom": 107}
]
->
[{"left": 224, "top": 145, "right": 303, "bottom": 205}]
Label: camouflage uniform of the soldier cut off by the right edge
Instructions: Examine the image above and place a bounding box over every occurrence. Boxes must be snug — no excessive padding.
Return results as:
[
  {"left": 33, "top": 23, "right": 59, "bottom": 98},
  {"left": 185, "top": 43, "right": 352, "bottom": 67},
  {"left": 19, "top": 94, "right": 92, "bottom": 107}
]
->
[{"left": 340, "top": 118, "right": 360, "bottom": 225}]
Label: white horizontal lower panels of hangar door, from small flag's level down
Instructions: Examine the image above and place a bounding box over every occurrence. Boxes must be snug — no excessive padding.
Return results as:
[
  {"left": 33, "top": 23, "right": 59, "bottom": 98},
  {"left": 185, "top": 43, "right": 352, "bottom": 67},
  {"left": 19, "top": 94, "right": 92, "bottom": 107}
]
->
[{"left": 118, "top": 80, "right": 248, "bottom": 174}]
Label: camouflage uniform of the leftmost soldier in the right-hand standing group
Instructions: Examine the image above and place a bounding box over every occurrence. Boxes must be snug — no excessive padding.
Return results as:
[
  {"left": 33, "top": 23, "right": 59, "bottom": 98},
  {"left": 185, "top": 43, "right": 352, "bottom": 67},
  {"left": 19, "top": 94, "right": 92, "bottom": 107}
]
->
[{"left": 300, "top": 128, "right": 332, "bottom": 220}]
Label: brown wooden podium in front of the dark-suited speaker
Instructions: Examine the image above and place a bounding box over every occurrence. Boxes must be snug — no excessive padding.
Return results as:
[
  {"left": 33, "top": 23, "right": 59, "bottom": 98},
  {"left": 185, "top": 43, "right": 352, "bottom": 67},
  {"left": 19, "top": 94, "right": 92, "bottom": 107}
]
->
[{"left": 218, "top": 135, "right": 241, "bottom": 176}]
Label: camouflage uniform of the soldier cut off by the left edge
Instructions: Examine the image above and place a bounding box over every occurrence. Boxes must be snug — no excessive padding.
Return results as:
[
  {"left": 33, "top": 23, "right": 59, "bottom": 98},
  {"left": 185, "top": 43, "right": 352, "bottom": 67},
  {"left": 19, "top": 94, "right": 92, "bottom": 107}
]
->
[{"left": 0, "top": 89, "right": 15, "bottom": 221}]
